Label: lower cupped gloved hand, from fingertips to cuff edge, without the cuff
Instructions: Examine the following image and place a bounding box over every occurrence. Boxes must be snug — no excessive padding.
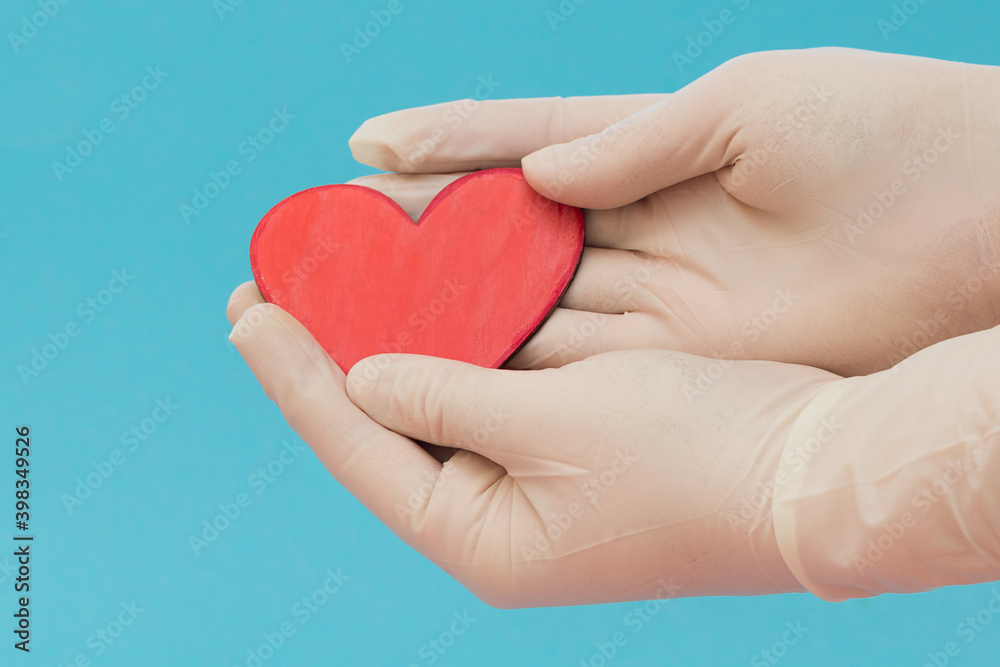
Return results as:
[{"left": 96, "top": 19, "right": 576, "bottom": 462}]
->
[{"left": 228, "top": 283, "right": 840, "bottom": 607}]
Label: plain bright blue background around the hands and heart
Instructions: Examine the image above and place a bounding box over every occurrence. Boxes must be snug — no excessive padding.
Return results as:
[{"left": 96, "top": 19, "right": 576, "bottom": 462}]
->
[{"left": 0, "top": 0, "right": 1000, "bottom": 666}]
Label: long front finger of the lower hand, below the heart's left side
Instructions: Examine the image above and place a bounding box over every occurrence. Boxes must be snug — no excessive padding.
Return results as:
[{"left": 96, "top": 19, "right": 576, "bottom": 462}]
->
[{"left": 230, "top": 304, "right": 442, "bottom": 543}]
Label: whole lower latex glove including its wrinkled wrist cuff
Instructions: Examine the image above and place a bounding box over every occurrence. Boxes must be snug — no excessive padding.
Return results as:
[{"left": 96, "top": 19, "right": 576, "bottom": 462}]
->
[{"left": 228, "top": 283, "right": 1000, "bottom": 607}]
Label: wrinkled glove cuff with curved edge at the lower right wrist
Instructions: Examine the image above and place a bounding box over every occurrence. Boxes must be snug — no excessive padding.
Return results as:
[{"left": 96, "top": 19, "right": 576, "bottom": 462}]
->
[{"left": 773, "top": 327, "right": 1000, "bottom": 601}]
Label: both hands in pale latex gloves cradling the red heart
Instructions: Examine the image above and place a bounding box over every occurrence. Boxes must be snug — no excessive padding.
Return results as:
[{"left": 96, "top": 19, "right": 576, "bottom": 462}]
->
[{"left": 228, "top": 49, "right": 1000, "bottom": 607}]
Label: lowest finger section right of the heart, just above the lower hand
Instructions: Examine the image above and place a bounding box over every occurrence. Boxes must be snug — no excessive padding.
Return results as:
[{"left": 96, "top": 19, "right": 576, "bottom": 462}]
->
[{"left": 504, "top": 308, "right": 691, "bottom": 370}]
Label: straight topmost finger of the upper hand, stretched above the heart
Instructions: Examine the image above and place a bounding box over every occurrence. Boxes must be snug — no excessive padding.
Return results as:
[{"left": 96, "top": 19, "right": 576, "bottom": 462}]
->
[{"left": 348, "top": 94, "right": 665, "bottom": 173}]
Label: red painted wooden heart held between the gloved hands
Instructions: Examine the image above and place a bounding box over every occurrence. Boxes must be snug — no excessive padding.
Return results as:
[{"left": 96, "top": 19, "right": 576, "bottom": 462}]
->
[{"left": 250, "top": 169, "right": 584, "bottom": 371}]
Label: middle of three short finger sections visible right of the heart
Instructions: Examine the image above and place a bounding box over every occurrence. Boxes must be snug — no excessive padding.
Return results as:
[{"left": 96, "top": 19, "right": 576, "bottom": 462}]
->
[{"left": 559, "top": 248, "right": 663, "bottom": 314}]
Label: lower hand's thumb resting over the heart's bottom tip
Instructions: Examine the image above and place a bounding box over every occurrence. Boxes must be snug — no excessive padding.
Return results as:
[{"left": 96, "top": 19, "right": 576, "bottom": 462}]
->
[{"left": 347, "top": 354, "right": 523, "bottom": 456}]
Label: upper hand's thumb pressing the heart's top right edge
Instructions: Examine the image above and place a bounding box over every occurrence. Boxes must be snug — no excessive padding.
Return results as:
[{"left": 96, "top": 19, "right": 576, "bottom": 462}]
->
[{"left": 521, "top": 60, "right": 746, "bottom": 209}]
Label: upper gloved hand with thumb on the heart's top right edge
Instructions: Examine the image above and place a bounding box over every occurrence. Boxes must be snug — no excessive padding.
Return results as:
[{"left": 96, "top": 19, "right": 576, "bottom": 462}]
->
[{"left": 350, "top": 49, "right": 1000, "bottom": 375}]
